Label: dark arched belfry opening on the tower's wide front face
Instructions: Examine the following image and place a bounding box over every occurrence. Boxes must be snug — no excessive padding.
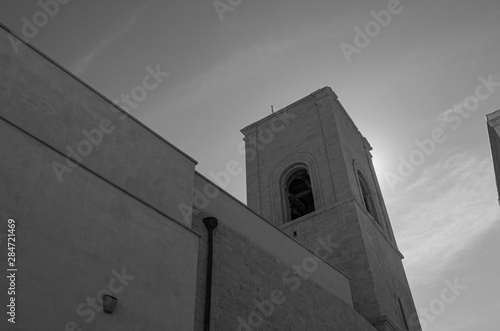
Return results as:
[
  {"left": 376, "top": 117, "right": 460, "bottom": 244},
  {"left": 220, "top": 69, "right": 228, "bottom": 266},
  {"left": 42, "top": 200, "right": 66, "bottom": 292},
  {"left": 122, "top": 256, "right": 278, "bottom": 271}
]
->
[{"left": 285, "top": 168, "right": 315, "bottom": 221}]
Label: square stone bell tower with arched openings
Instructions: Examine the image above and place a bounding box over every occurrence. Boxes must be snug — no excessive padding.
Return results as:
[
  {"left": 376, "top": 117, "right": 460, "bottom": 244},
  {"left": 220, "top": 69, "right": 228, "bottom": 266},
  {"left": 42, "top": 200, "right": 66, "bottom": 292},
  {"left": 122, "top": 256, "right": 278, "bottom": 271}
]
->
[{"left": 241, "top": 87, "right": 420, "bottom": 331}]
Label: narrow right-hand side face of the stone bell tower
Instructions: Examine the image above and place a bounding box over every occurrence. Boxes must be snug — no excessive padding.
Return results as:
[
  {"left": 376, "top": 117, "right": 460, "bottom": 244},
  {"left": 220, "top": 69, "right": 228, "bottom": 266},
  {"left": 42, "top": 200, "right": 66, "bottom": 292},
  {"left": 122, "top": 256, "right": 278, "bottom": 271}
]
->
[{"left": 334, "top": 92, "right": 419, "bottom": 330}]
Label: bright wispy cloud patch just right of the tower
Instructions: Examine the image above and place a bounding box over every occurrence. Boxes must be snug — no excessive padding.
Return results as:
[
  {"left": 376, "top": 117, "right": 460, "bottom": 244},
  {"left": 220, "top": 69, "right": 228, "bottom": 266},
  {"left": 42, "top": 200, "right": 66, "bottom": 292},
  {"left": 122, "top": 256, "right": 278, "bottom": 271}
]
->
[{"left": 389, "top": 148, "right": 500, "bottom": 285}]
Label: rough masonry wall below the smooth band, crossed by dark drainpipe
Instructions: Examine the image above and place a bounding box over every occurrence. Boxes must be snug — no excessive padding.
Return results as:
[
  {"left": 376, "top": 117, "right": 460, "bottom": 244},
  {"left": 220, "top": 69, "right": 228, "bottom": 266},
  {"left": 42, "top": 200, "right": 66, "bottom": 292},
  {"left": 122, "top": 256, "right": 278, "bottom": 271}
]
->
[{"left": 193, "top": 217, "right": 375, "bottom": 331}]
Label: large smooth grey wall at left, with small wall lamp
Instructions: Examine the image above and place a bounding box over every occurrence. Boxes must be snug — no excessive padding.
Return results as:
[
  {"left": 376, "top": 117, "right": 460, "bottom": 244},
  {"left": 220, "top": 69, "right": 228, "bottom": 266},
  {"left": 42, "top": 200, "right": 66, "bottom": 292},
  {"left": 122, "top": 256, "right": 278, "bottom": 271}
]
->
[{"left": 0, "top": 24, "right": 198, "bottom": 331}]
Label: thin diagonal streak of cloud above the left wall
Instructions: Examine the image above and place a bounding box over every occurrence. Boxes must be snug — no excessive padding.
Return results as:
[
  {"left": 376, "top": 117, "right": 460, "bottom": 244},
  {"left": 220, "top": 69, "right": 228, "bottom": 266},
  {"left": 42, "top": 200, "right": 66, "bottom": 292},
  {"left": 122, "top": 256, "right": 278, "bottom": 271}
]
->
[{"left": 73, "top": 0, "right": 158, "bottom": 74}]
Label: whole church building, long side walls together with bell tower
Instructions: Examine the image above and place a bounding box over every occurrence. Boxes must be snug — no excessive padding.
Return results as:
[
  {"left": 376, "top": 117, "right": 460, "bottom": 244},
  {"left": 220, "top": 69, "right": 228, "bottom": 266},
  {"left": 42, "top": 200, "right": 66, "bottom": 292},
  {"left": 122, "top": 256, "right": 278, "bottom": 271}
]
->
[{"left": 0, "top": 22, "right": 421, "bottom": 331}]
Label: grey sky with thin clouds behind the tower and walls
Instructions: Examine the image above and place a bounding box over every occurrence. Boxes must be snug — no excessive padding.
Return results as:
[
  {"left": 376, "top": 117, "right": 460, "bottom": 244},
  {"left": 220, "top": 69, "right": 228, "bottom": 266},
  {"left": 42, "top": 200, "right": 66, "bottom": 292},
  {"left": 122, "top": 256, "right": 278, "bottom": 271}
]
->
[{"left": 0, "top": 0, "right": 500, "bottom": 331}]
